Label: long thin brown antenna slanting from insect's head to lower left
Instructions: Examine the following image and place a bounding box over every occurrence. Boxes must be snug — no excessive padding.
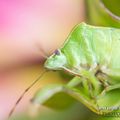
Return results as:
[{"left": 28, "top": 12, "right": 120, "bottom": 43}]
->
[{"left": 8, "top": 70, "right": 47, "bottom": 119}]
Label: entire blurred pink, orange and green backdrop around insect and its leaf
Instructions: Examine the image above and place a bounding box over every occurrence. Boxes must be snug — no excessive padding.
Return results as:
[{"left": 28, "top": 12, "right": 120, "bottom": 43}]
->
[{"left": 0, "top": 0, "right": 120, "bottom": 120}]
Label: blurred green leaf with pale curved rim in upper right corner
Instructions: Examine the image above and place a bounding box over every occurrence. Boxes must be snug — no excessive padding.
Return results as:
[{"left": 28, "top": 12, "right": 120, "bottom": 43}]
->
[{"left": 85, "top": 0, "right": 120, "bottom": 28}]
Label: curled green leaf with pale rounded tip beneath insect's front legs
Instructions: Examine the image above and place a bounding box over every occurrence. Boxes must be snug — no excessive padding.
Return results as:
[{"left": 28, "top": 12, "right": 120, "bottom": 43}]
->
[{"left": 32, "top": 81, "right": 100, "bottom": 112}]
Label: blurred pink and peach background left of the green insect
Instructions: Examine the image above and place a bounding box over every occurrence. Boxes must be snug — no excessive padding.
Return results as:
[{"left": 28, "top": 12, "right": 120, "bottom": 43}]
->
[{"left": 0, "top": 0, "right": 84, "bottom": 119}]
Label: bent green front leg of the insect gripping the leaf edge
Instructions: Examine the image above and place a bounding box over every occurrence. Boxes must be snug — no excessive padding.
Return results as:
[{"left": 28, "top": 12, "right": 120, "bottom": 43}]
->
[{"left": 67, "top": 77, "right": 100, "bottom": 114}]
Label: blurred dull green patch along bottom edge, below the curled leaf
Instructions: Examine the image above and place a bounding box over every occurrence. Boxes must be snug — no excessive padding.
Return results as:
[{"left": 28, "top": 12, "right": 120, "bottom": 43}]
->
[{"left": 13, "top": 103, "right": 91, "bottom": 120}]
